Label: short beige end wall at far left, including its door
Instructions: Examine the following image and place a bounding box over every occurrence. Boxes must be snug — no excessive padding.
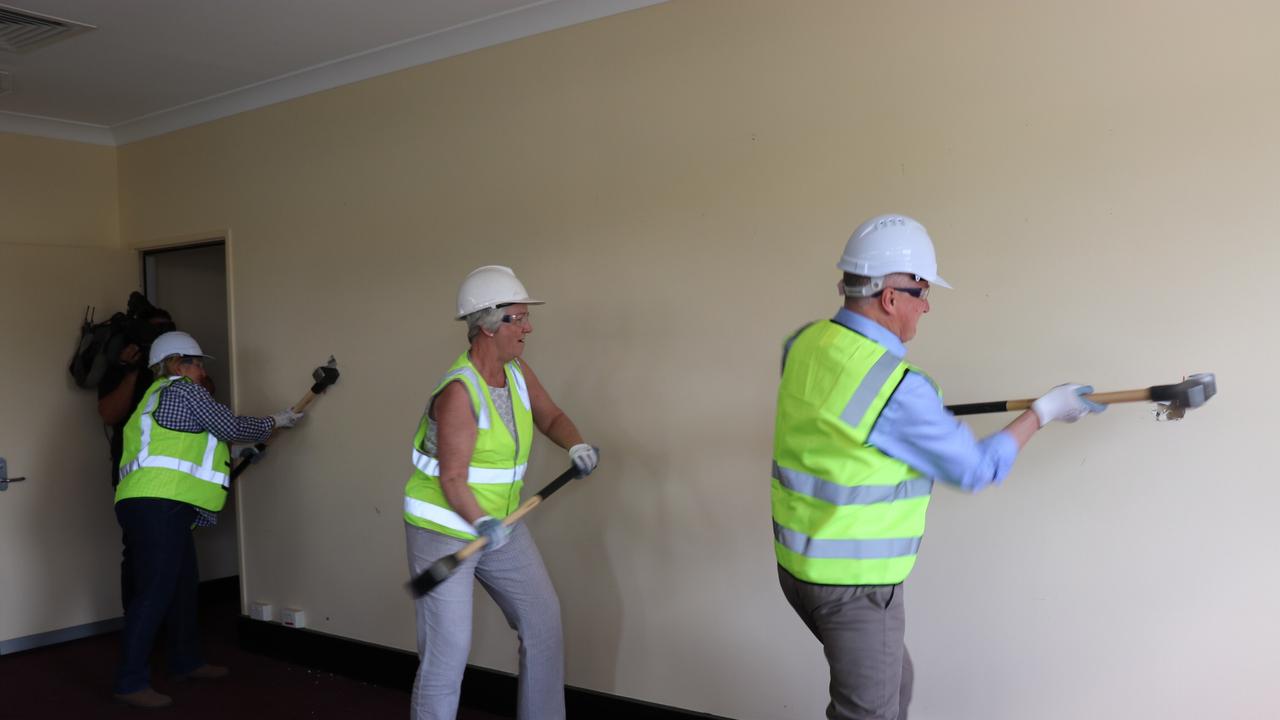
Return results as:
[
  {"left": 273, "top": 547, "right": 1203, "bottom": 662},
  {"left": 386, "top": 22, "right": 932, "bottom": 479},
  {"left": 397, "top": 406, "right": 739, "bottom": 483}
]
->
[{"left": 0, "top": 133, "right": 137, "bottom": 643}]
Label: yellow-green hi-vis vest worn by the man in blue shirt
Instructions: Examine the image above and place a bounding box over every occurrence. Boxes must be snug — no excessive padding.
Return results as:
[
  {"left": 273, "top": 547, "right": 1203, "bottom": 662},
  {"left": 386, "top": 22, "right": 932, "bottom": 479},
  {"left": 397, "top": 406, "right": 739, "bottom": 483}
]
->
[{"left": 771, "top": 322, "right": 933, "bottom": 585}]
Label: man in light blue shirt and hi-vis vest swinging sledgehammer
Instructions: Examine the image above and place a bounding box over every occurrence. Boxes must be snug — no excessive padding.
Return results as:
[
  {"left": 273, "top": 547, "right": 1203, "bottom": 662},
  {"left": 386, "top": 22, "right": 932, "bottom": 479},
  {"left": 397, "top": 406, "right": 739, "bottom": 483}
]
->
[{"left": 772, "top": 215, "right": 1103, "bottom": 720}]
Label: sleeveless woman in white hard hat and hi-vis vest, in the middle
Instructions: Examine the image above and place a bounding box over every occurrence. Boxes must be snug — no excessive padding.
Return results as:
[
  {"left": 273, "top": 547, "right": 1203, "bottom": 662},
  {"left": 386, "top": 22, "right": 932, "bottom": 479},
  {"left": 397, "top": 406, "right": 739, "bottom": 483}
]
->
[{"left": 404, "top": 265, "right": 598, "bottom": 720}]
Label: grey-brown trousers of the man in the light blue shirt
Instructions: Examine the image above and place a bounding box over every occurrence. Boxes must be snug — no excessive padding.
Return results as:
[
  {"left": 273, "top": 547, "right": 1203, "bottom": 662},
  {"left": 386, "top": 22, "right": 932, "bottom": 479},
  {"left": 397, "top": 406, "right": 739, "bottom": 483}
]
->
[{"left": 778, "top": 566, "right": 915, "bottom": 720}]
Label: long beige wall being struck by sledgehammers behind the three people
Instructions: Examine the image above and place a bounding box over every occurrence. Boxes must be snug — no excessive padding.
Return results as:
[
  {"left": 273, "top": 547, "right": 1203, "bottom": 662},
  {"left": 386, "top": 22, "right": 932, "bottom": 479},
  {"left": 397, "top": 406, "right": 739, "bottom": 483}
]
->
[{"left": 119, "top": 0, "right": 1280, "bottom": 720}]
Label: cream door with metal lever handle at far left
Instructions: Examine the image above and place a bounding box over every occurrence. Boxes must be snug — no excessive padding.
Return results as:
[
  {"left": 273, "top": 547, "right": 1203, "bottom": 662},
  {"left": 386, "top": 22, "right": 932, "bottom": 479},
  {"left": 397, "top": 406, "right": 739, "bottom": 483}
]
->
[{"left": 0, "top": 243, "right": 138, "bottom": 653}]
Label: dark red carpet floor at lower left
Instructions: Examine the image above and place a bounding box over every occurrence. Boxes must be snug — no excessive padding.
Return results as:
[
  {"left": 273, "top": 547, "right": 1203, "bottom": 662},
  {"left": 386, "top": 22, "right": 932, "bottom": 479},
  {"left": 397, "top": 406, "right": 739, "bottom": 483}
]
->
[{"left": 0, "top": 582, "right": 506, "bottom": 720}]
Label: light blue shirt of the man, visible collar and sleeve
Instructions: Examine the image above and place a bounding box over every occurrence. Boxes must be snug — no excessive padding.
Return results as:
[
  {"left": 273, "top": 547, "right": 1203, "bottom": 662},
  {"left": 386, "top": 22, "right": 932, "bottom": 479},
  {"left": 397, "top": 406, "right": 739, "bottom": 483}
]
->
[{"left": 832, "top": 307, "right": 1018, "bottom": 492}]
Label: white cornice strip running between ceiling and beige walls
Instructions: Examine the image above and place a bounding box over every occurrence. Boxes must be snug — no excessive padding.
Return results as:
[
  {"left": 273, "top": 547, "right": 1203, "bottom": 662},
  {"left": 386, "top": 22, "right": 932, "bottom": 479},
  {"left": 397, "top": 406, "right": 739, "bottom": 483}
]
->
[{"left": 0, "top": 0, "right": 666, "bottom": 145}]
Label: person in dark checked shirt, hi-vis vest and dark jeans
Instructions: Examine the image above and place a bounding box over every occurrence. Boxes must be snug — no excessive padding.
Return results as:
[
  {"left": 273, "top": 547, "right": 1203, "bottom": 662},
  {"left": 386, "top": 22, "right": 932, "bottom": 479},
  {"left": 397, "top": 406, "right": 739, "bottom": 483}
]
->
[{"left": 108, "top": 332, "right": 302, "bottom": 707}]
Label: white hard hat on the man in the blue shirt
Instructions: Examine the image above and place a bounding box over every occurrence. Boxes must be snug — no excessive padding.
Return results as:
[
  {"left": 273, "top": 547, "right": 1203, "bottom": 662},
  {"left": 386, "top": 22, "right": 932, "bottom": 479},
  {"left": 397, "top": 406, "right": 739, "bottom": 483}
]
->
[{"left": 836, "top": 215, "right": 951, "bottom": 295}]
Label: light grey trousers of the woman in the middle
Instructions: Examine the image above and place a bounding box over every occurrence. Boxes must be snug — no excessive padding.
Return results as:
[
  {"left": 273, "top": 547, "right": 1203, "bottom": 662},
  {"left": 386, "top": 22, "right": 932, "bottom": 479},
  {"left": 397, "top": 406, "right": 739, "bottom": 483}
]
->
[{"left": 404, "top": 523, "right": 564, "bottom": 720}]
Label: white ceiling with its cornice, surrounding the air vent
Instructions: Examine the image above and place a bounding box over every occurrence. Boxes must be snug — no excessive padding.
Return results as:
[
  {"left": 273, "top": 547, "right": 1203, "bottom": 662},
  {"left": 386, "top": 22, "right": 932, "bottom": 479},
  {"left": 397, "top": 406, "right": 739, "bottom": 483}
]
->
[{"left": 0, "top": 0, "right": 660, "bottom": 145}]
